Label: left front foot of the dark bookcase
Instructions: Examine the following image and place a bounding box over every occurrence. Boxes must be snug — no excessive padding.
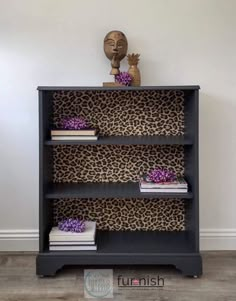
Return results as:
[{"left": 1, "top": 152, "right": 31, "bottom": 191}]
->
[{"left": 36, "top": 255, "right": 63, "bottom": 277}]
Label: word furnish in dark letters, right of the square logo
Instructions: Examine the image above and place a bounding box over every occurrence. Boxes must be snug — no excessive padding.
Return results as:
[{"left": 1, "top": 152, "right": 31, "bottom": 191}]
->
[{"left": 117, "top": 275, "right": 165, "bottom": 289}]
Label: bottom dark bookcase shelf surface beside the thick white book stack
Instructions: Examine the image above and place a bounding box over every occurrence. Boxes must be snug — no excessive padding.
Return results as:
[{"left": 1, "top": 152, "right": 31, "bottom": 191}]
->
[{"left": 44, "top": 230, "right": 194, "bottom": 256}]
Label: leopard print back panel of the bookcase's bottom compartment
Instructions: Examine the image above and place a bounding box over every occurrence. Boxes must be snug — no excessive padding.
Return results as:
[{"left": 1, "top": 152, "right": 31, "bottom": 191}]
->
[{"left": 53, "top": 199, "right": 185, "bottom": 231}]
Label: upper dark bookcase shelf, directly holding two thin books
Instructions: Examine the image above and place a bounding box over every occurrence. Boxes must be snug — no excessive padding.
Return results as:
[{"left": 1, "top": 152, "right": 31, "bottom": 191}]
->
[{"left": 45, "top": 136, "right": 193, "bottom": 145}]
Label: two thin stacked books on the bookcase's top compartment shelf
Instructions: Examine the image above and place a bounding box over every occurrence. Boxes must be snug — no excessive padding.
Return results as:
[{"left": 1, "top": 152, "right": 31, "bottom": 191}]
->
[{"left": 51, "top": 129, "right": 98, "bottom": 141}]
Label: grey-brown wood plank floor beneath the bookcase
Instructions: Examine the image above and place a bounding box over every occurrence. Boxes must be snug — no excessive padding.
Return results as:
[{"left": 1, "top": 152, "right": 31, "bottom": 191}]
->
[{"left": 0, "top": 251, "right": 236, "bottom": 301}]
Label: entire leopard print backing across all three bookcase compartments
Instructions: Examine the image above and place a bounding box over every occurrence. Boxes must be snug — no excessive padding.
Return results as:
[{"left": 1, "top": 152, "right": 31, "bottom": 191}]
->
[{"left": 53, "top": 90, "right": 185, "bottom": 231}]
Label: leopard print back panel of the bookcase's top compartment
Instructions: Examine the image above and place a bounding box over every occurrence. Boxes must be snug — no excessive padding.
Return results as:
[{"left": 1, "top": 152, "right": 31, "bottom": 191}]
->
[{"left": 53, "top": 90, "right": 184, "bottom": 136}]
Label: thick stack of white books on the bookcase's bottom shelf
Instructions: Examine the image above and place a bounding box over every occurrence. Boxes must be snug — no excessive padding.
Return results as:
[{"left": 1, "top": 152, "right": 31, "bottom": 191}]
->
[{"left": 49, "top": 221, "right": 97, "bottom": 251}]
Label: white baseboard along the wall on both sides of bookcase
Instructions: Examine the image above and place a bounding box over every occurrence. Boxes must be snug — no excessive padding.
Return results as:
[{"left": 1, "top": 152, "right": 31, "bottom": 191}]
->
[{"left": 0, "top": 229, "right": 236, "bottom": 251}]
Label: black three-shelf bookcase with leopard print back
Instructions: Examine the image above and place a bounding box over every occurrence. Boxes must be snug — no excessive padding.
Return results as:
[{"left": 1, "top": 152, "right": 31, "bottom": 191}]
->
[{"left": 36, "top": 86, "right": 202, "bottom": 276}]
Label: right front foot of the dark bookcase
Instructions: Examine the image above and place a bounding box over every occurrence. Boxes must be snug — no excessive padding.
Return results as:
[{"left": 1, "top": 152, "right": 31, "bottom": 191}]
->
[{"left": 175, "top": 255, "right": 202, "bottom": 278}]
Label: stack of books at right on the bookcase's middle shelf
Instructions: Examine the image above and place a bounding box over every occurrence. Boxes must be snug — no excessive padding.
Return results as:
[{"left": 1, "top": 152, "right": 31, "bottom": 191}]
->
[{"left": 139, "top": 176, "right": 188, "bottom": 193}]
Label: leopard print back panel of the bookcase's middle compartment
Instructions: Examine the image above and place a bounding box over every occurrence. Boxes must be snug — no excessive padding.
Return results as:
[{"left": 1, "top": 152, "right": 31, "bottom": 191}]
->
[{"left": 53, "top": 145, "right": 184, "bottom": 183}]
